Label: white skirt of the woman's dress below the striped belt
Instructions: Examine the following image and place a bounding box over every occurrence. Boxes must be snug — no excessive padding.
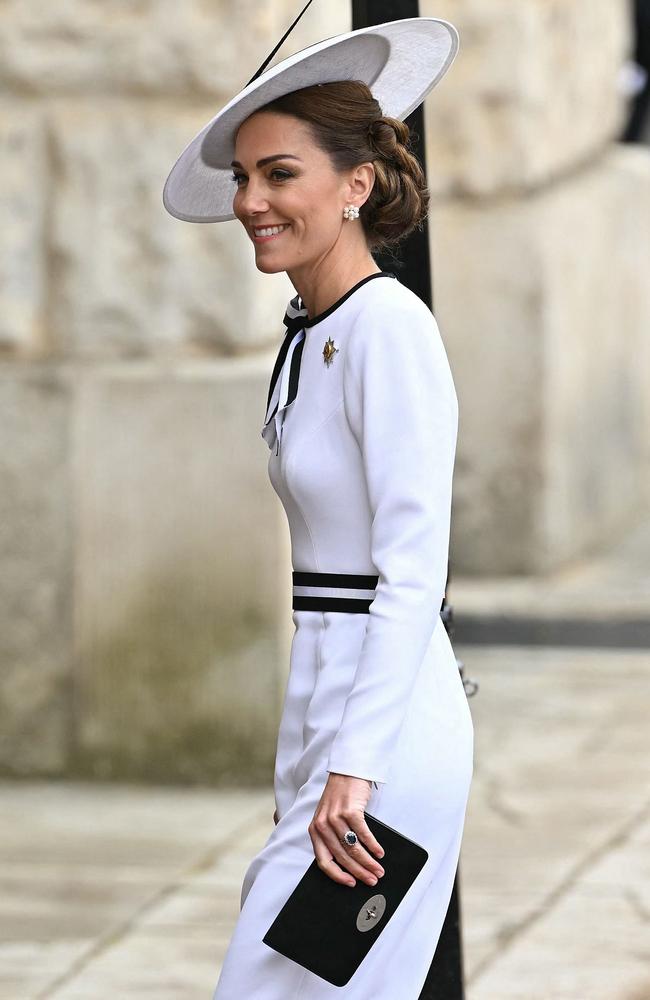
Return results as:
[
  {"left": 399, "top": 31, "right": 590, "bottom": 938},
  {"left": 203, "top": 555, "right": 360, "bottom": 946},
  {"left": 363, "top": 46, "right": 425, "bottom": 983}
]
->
[{"left": 214, "top": 611, "right": 473, "bottom": 1000}]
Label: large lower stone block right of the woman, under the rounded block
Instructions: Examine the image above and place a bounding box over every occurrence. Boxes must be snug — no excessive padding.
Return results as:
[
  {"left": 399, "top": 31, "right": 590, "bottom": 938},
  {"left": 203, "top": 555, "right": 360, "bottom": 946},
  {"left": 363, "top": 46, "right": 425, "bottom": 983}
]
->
[{"left": 430, "top": 144, "right": 650, "bottom": 575}]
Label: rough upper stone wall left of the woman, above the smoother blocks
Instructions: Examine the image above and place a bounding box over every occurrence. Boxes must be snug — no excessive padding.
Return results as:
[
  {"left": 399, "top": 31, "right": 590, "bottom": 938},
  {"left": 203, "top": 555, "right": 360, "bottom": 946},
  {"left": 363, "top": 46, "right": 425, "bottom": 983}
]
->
[{"left": 0, "top": 0, "right": 349, "bottom": 360}]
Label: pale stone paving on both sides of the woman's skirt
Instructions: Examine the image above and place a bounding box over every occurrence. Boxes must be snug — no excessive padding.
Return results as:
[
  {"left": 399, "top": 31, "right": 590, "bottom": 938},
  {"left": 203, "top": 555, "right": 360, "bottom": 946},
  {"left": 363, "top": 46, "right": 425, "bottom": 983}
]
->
[{"left": 0, "top": 644, "right": 650, "bottom": 1000}]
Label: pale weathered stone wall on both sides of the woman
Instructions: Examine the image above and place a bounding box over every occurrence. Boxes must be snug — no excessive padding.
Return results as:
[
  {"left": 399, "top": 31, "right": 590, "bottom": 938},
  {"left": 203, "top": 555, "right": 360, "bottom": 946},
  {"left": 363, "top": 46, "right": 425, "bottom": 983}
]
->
[{"left": 0, "top": 0, "right": 650, "bottom": 784}]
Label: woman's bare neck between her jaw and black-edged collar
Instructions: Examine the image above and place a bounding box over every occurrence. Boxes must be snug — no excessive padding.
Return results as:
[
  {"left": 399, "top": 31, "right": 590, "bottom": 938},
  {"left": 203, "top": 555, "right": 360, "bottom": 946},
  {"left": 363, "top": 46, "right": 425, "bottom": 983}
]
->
[{"left": 287, "top": 247, "right": 381, "bottom": 319}]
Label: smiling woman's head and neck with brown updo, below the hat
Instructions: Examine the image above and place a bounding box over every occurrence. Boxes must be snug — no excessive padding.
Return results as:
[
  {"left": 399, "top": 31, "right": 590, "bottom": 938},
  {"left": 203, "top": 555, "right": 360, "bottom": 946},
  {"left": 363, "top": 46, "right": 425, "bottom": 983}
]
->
[{"left": 232, "top": 80, "right": 429, "bottom": 315}]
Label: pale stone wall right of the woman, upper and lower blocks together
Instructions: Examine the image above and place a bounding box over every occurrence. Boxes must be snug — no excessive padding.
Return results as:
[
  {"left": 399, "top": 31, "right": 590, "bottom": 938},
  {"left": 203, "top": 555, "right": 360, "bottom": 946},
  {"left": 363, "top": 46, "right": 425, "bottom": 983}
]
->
[{"left": 420, "top": 0, "right": 650, "bottom": 575}]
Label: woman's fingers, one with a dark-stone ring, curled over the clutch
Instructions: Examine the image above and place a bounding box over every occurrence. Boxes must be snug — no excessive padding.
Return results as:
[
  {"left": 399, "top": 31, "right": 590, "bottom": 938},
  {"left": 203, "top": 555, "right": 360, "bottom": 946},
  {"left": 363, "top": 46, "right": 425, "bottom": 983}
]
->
[{"left": 309, "top": 813, "right": 384, "bottom": 885}]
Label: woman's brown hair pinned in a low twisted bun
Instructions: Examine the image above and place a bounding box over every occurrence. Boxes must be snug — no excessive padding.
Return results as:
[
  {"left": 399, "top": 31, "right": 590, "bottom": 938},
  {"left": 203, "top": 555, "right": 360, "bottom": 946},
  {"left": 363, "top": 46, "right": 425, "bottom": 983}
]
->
[{"left": 259, "top": 80, "right": 429, "bottom": 250}]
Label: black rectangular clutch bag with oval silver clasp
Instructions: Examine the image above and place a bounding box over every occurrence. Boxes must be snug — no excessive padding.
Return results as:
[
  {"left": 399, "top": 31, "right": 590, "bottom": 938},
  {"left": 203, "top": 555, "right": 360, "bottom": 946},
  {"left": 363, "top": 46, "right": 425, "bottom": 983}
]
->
[{"left": 262, "top": 812, "right": 429, "bottom": 986}]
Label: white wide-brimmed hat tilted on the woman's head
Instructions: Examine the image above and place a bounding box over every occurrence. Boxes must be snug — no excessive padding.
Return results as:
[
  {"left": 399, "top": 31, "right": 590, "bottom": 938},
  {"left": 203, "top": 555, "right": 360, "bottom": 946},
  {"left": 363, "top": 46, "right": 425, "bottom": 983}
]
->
[{"left": 163, "top": 17, "right": 459, "bottom": 222}]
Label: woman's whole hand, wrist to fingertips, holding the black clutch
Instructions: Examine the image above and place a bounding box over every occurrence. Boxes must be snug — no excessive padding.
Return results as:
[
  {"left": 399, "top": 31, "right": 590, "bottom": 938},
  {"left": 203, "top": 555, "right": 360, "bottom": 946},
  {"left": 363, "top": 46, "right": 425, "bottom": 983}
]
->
[{"left": 309, "top": 772, "right": 384, "bottom": 886}]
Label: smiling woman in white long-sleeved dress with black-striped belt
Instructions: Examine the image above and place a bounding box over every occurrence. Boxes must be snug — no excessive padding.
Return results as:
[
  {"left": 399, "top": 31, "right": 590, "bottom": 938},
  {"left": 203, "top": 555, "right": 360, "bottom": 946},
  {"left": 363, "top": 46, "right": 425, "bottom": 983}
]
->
[{"left": 166, "top": 19, "right": 473, "bottom": 1000}]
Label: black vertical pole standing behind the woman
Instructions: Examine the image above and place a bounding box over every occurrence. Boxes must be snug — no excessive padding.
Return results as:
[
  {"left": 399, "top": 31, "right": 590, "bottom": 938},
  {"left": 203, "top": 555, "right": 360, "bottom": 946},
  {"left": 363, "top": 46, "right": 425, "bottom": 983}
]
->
[{"left": 352, "top": 0, "right": 465, "bottom": 1000}]
